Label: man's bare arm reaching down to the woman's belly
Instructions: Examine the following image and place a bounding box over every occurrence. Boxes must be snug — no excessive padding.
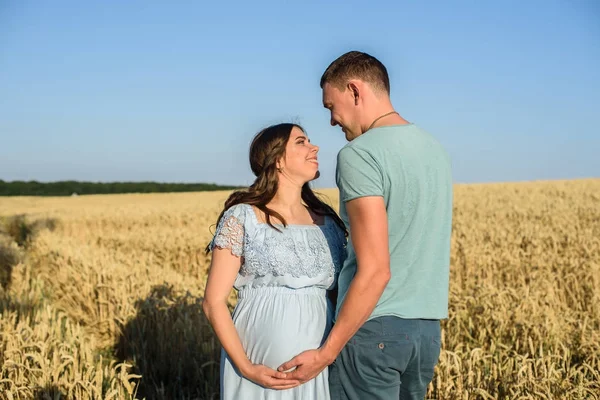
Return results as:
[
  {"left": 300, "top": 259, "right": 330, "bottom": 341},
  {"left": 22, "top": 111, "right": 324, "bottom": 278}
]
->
[{"left": 279, "top": 196, "right": 391, "bottom": 382}]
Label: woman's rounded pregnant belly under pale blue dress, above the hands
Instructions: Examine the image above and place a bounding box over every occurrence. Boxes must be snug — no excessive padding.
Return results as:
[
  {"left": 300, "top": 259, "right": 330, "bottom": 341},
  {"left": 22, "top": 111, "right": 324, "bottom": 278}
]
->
[{"left": 233, "top": 288, "right": 332, "bottom": 369}]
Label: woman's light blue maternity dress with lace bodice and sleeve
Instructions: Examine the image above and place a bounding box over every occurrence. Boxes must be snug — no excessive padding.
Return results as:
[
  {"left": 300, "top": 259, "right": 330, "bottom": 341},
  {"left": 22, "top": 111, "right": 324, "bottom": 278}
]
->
[{"left": 211, "top": 204, "right": 346, "bottom": 400}]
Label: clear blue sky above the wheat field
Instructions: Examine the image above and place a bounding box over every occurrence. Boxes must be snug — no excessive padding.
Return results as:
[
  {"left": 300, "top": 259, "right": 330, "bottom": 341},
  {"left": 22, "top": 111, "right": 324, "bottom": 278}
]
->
[{"left": 0, "top": 0, "right": 600, "bottom": 187}]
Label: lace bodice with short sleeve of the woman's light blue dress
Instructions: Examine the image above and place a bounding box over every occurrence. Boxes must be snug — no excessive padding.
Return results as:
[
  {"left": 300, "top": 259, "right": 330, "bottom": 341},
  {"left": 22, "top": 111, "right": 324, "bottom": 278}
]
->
[{"left": 211, "top": 204, "right": 346, "bottom": 290}]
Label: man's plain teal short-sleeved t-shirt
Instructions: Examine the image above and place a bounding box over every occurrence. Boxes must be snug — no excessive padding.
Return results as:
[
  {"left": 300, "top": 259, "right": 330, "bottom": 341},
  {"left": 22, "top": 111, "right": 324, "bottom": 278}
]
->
[{"left": 336, "top": 124, "right": 452, "bottom": 319}]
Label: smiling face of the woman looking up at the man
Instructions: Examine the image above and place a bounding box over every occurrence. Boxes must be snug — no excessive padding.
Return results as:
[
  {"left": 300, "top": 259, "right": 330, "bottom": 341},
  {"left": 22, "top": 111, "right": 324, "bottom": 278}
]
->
[{"left": 279, "top": 126, "right": 319, "bottom": 184}]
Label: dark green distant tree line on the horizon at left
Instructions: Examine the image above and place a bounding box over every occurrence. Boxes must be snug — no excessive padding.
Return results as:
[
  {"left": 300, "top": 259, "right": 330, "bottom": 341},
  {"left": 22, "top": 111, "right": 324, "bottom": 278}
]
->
[{"left": 0, "top": 179, "right": 244, "bottom": 196}]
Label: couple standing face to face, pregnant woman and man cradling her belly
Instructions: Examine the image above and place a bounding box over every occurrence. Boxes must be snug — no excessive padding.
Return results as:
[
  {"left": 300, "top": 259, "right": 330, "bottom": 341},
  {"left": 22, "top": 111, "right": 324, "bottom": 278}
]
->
[{"left": 203, "top": 51, "right": 453, "bottom": 400}]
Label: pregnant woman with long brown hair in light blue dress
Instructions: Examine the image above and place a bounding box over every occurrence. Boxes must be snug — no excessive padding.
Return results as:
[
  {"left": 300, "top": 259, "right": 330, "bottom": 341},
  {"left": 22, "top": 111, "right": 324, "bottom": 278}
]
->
[{"left": 203, "top": 124, "right": 346, "bottom": 400}]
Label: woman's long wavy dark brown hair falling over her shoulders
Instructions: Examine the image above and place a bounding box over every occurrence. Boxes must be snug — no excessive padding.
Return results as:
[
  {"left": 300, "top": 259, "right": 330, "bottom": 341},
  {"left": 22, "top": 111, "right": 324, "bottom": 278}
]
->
[{"left": 206, "top": 123, "right": 348, "bottom": 254}]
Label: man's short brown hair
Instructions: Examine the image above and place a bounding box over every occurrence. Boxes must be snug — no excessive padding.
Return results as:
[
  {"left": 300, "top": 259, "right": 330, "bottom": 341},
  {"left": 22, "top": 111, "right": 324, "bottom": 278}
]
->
[{"left": 321, "top": 51, "right": 390, "bottom": 95}]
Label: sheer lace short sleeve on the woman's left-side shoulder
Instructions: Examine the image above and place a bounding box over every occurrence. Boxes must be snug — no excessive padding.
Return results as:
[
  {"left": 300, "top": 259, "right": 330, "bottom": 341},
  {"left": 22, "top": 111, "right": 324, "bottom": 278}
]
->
[{"left": 210, "top": 204, "right": 246, "bottom": 257}]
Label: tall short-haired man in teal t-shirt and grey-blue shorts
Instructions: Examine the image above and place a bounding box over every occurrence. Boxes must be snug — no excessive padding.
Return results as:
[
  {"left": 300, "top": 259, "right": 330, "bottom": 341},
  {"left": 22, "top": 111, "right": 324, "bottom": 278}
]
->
[{"left": 280, "top": 51, "right": 452, "bottom": 400}]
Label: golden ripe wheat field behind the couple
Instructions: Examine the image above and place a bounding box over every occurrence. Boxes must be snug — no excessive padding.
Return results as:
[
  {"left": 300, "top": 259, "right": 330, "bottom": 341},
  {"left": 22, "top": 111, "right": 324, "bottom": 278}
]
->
[{"left": 0, "top": 179, "right": 600, "bottom": 400}]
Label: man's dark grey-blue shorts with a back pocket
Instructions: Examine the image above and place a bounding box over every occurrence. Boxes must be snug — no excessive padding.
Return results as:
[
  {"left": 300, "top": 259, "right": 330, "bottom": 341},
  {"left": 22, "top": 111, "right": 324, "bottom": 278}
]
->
[{"left": 329, "top": 316, "right": 441, "bottom": 400}]
